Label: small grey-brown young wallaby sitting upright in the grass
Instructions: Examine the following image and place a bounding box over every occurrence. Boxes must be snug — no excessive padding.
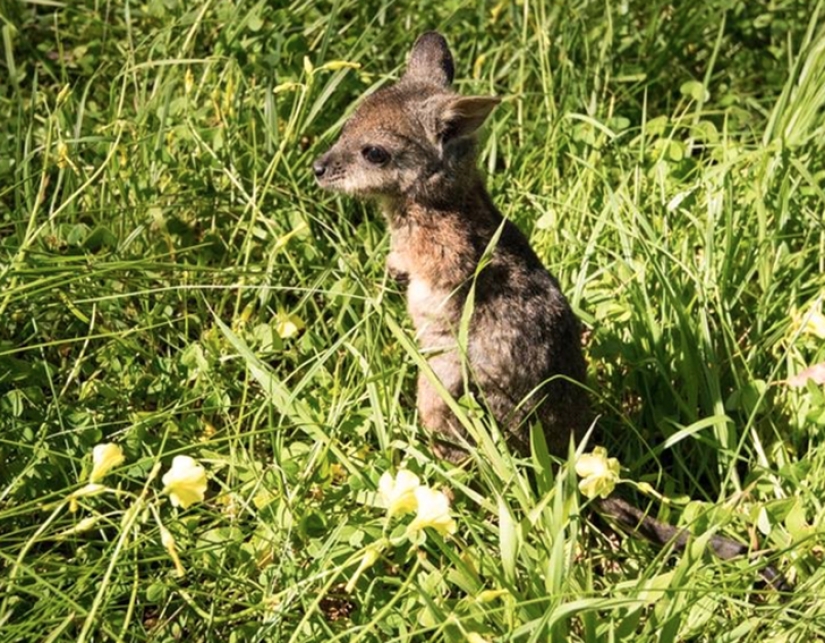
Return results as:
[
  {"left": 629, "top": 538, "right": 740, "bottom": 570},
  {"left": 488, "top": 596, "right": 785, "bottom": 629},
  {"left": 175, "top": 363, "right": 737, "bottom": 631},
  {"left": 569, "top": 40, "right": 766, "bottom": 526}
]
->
[{"left": 312, "top": 32, "right": 781, "bottom": 585}]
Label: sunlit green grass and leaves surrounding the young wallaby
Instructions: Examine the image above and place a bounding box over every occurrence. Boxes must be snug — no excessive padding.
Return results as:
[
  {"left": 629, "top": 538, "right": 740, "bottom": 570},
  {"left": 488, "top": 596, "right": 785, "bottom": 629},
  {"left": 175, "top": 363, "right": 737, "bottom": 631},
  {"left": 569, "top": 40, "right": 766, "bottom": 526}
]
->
[{"left": 0, "top": 0, "right": 825, "bottom": 643}]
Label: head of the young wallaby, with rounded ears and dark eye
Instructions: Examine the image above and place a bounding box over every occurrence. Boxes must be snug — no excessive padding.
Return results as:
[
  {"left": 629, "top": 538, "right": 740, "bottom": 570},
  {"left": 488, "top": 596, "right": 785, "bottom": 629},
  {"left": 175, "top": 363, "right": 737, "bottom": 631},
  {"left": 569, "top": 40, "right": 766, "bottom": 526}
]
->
[{"left": 312, "top": 32, "right": 499, "bottom": 204}]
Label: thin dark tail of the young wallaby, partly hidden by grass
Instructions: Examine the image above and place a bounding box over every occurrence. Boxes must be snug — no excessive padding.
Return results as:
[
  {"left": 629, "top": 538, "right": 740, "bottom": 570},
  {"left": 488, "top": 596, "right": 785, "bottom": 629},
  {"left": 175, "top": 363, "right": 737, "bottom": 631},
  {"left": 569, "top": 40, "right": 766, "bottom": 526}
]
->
[{"left": 596, "top": 498, "right": 792, "bottom": 591}]
